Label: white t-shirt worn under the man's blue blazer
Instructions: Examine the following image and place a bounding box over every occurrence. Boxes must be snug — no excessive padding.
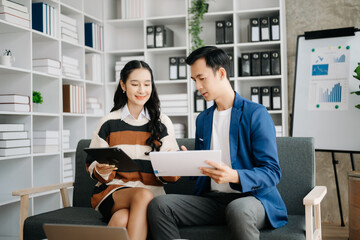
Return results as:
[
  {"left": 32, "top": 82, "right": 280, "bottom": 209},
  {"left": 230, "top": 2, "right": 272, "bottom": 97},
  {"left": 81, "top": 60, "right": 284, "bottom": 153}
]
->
[{"left": 210, "top": 108, "right": 239, "bottom": 193}]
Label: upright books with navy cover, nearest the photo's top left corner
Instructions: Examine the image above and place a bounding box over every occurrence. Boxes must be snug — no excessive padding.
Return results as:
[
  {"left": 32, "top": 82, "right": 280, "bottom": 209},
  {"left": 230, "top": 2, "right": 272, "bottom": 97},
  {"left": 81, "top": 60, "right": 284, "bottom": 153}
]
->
[{"left": 32, "top": 2, "right": 57, "bottom": 37}]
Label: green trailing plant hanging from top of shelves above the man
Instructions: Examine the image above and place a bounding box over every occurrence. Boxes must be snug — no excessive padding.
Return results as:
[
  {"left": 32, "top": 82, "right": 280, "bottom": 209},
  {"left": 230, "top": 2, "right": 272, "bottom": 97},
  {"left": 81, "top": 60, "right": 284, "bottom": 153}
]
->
[{"left": 189, "top": 0, "right": 209, "bottom": 51}]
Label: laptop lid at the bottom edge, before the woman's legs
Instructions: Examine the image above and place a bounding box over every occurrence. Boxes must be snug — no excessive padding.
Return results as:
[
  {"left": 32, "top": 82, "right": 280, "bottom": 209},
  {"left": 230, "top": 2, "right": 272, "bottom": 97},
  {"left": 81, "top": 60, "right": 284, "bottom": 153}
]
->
[{"left": 43, "top": 223, "right": 130, "bottom": 240}]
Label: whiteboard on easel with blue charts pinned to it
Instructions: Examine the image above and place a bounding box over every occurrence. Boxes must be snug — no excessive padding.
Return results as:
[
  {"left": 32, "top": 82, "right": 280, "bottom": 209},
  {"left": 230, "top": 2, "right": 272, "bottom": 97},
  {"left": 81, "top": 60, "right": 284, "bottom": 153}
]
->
[{"left": 292, "top": 32, "right": 360, "bottom": 151}]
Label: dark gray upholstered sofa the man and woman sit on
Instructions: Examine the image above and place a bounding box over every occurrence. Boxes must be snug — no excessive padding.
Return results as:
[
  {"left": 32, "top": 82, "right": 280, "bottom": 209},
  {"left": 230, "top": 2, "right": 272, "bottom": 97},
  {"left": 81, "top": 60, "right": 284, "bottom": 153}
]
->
[{"left": 15, "top": 137, "right": 326, "bottom": 240}]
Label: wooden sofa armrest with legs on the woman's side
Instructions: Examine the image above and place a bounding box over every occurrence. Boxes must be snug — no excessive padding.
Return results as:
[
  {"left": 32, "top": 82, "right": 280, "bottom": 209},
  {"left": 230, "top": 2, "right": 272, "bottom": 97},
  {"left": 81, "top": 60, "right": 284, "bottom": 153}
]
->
[{"left": 12, "top": 182, "right": 74, "bottom": 240}]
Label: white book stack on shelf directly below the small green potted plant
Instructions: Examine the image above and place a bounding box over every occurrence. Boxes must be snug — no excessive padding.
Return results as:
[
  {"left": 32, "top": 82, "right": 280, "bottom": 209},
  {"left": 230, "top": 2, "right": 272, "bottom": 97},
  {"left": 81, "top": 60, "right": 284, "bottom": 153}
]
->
[{"left": 33, "top": 130, "right": 59, "bottom": 153}]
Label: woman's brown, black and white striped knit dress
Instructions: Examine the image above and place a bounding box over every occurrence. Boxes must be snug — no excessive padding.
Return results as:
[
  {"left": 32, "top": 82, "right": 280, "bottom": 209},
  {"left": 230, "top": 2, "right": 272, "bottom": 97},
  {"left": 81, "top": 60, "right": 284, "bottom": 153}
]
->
[{"left": 86, "top": 106, "right": 179, "bottom": 210}]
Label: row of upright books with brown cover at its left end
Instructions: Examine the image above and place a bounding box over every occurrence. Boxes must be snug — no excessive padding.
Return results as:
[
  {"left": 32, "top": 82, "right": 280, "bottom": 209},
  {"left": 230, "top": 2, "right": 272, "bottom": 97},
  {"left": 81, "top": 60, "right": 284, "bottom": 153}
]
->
[{"left": 63, "top": 84, "right": 85, "bottom": 113}]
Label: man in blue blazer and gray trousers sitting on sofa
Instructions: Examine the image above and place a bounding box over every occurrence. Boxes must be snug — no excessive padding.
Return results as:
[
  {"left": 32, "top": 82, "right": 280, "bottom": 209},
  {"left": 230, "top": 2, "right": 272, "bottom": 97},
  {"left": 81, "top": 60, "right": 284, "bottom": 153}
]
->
[{"left": 148, "top": 46, "right": 287, "bottom": 240}]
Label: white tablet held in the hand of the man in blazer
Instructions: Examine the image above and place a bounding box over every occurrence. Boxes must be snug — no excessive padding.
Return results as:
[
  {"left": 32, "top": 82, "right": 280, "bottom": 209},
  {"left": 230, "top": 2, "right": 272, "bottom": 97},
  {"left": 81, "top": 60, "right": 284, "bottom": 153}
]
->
[{"left": 150, "top": 150, "right": 221, "bottom": 176}]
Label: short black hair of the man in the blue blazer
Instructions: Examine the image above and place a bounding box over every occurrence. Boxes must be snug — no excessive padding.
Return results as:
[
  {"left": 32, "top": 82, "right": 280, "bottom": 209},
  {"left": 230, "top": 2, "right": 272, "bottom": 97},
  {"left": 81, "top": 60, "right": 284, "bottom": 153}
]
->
[{"left": 185, "top": 46, "right": 230, "bottom": 80}]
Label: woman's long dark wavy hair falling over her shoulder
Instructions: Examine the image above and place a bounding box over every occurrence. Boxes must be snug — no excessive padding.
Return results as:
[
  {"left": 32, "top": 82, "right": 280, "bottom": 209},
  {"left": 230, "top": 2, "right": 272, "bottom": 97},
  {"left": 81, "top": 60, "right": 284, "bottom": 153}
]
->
[{"left": 110, "top": 60, "right": 162, "bottom": 154}]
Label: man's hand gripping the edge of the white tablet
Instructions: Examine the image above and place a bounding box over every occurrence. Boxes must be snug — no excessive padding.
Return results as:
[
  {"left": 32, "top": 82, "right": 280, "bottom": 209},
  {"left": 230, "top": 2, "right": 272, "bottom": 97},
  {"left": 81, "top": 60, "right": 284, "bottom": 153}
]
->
[{"left": 200, "top": 161, "right": 240, "bottom": 184}]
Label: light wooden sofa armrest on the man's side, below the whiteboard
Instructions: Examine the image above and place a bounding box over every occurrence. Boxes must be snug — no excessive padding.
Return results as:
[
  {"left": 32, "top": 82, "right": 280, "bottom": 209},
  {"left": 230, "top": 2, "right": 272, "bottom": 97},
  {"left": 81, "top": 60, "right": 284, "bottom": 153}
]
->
[{"left": 303, "top": 186, "right": 327, "bottom": 240}]
